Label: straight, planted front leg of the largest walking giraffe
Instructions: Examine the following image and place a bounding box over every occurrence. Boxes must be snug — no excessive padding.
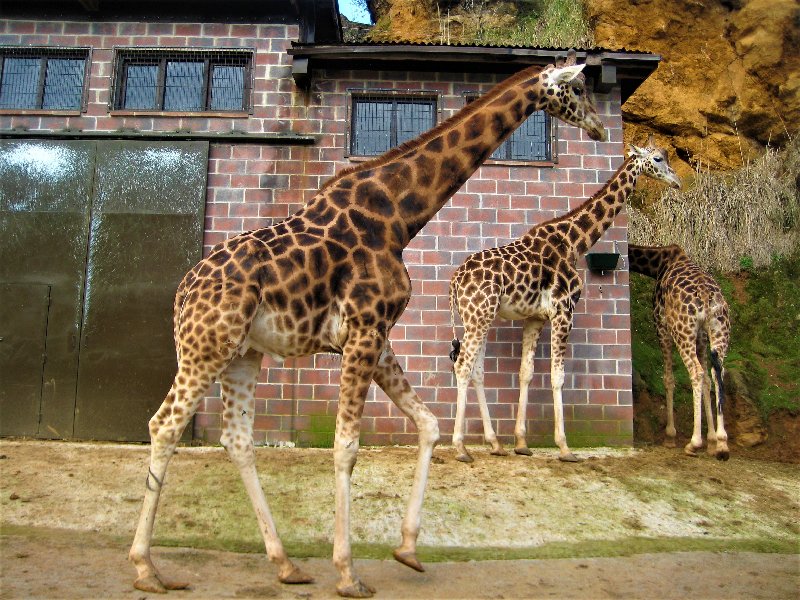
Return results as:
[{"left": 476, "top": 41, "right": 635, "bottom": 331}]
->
[{"left": 333, "top": 328, "right": 386, "bottom": 598}]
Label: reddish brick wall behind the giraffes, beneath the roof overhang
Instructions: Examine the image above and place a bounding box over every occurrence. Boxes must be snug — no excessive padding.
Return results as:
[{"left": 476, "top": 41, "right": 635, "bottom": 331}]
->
[{"left": 195, "top": 71, "right": 633, "bottom": 445}]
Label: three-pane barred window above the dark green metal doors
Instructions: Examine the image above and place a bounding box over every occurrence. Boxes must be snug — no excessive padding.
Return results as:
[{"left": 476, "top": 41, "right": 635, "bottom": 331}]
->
[{"left": 114, "top": 49, "right": 253, "bottom": 112}]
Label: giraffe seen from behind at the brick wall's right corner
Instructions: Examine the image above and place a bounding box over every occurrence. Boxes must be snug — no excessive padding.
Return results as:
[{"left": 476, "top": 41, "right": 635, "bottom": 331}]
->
[{"left": 628, "top": 244, "right": 731, "bottom": 460}]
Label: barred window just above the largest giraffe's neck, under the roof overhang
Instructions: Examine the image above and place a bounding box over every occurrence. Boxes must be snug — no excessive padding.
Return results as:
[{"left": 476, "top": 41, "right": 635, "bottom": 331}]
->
[{"left": 350, "top": 92, "right": 436, "bottom": 156}]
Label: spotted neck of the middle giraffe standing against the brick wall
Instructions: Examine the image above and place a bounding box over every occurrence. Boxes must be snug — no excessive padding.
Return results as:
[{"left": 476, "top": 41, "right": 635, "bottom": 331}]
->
[{"left": 529, "top": 157, "right": 642, "bottom": 259}]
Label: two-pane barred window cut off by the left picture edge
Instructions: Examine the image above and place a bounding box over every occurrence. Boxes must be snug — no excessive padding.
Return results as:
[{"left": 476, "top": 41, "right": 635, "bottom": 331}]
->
[{"left": 0, "top": 47, "right": 89, "bottom": 111}]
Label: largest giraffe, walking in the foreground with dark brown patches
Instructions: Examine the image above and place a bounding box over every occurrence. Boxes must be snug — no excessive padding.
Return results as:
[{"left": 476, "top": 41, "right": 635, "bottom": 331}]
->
[{"left": 130, "top": 54, "right": 605, "bottom": 597}]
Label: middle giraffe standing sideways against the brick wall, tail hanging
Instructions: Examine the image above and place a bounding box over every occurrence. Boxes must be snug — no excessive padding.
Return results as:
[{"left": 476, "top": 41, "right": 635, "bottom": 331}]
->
[{"left": 450, "top": 139, "right": 680, "bottom": 462}]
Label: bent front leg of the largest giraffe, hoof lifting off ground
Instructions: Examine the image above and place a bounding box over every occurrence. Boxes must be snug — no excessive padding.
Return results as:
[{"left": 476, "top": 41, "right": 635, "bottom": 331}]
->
[{"left": 375, "top": 343, "right": 439, "bottom": 571}]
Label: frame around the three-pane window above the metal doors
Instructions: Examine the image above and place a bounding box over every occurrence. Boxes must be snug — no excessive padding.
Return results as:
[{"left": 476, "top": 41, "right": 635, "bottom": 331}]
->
[{"left": 108, "top": 46, "right": 256, "bottom": 118}]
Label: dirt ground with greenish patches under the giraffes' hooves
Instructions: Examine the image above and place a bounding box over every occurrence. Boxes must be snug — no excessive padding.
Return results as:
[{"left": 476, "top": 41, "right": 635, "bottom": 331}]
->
[{"left": 0, "top": 440, "right": 800, "bottom": 600}]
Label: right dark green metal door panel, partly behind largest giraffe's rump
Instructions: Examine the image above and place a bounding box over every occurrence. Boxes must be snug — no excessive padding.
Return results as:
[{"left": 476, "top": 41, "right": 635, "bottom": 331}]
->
[{"left": 74, "top": 142, "right": 208, "bottom": 441}]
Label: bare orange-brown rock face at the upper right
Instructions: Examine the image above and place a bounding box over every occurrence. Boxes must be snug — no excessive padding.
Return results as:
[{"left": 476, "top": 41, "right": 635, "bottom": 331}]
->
[{"left": 586, "top": 0, "right": 800, "bottom": 169}]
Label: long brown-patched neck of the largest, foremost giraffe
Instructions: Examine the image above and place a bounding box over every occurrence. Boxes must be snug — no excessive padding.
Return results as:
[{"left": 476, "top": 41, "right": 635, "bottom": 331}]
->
[{"left": 308, "top": 62, "right": 553, "bottom": 248}]
